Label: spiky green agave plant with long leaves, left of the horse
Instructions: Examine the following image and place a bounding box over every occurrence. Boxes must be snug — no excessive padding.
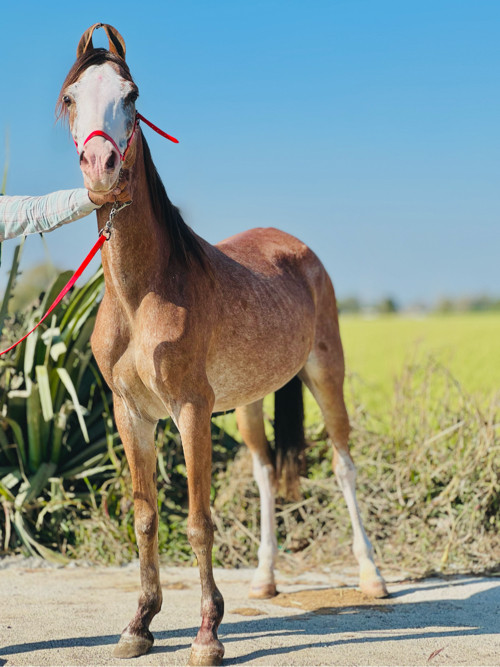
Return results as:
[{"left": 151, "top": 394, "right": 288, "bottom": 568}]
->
[{"left": 0, "top": 258, "right": 116, "bottom": 560}]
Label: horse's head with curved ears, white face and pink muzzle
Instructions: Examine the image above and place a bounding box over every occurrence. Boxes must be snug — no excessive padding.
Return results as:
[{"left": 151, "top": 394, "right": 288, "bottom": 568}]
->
[{"left": 58, "top": 23, "right": 139, "bottom": 193}]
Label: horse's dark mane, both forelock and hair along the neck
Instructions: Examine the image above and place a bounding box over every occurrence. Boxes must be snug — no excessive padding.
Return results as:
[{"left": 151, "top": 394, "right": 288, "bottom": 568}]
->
[{"left": 56, "top": 48, "right": 211, "bottom": 274}]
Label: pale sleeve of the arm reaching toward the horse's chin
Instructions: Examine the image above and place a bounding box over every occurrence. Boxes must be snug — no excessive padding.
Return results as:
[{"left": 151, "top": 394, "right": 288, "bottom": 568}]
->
[{"left": 0, "top": 188, "right": 100, "bottom": 241}]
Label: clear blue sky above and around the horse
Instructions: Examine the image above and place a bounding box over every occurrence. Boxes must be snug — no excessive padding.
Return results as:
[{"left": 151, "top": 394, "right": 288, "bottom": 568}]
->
[{"left": 0, "top": 0, "right": 500, "bottom": 304}]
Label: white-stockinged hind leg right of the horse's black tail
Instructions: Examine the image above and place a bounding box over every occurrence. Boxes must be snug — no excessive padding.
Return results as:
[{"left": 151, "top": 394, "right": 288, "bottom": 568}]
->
[{"left": 300, "top": 350, "right": 388, "bottom": 598}]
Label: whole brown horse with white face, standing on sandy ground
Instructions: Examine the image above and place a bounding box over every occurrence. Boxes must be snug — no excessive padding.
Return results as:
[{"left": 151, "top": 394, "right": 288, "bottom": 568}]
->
[{"left": 59, "top": 24, "right": 387, "bottom": 665}]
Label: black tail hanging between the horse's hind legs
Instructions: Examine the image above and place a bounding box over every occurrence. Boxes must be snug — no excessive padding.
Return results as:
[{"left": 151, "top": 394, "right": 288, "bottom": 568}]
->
[{"left": 274, "top": 376, "right": 306, "bottom": 499}]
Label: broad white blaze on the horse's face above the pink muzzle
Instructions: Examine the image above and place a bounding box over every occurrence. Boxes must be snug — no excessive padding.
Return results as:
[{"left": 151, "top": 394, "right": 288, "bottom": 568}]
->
[{"left": 66, "top": 63, "right": 134, "bottom": 159}]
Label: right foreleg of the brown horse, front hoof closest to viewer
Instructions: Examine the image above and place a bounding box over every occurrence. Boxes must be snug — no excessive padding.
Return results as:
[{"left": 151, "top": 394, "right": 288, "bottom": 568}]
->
[{"left": 178, "top": 402, "right": 224, "bottom": 665}]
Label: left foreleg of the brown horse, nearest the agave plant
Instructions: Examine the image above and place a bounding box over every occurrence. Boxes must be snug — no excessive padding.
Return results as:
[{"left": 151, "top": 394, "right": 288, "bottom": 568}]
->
[{"left": 113, "top": 398, "right": 162, "bottom": 658}]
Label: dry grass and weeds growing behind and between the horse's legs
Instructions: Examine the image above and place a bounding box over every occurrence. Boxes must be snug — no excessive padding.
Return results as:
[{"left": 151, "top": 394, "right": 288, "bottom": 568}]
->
[{"left": 51, "top": 361, "right": 500, "bottom": 576}]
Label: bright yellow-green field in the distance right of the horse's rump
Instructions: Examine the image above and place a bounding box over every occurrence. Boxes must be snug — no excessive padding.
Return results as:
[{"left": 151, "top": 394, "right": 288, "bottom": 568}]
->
[{"left": 340, "top": 313, "right": 500, "bottom": 406}]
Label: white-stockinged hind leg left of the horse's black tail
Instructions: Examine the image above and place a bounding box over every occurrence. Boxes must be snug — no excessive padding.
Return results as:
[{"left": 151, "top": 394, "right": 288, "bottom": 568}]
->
[{"left": 236, "top": 401, "right": 278, "bottom": 599}]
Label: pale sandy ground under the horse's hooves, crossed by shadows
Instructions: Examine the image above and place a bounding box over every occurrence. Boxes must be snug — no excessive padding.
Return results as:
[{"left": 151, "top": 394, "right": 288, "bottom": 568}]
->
[{"left": 0, "top": 559, "right": 500, "bottom": 667}]
